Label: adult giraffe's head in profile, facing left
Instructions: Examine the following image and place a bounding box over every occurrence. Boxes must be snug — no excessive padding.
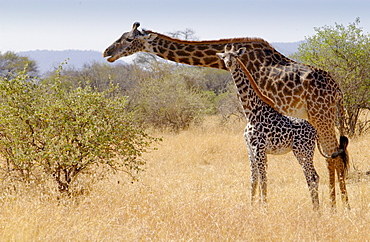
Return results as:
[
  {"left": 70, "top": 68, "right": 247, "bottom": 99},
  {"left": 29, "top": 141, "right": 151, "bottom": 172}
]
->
[{"left": 103, "top": 22, "right": 157, "bottom": 62}]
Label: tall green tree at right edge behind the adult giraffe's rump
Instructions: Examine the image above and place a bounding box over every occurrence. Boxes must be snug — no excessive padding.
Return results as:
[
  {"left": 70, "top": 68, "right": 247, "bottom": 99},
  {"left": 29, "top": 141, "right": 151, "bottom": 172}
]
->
[{"left": 293, "top": 18, "right": 370, "bottom": 136}]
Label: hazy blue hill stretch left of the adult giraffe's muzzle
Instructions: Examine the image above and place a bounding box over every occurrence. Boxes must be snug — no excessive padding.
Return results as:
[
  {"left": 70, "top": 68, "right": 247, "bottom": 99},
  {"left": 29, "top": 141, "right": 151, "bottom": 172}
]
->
[{"left": 18, "top": 50, "right": 124, "bottom": 75}]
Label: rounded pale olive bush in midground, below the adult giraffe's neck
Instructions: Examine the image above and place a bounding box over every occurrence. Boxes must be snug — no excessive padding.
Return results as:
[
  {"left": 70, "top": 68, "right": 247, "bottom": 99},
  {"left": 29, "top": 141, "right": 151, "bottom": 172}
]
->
[{"left": 132, "top": 65, "right": 211, "bottom": 131}]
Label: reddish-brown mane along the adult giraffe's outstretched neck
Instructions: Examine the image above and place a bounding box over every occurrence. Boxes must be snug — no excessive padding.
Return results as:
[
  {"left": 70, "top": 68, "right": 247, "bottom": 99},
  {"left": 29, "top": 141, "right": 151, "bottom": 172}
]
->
[{"left": 144, "top": 30, "right": 274, "bottom": 49}]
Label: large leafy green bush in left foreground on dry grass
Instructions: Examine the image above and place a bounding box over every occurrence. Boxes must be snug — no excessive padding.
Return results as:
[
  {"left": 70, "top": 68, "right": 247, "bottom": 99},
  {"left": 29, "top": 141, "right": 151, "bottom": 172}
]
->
[{"left": 0, "top": 70, "right": 156, "bottom": 193}]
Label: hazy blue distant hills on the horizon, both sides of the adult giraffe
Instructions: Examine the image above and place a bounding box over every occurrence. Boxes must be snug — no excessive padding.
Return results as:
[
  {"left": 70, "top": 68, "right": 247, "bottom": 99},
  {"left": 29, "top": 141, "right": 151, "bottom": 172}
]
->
[{"left": 18, "top": 41, "right": 303, "bottom": 75}]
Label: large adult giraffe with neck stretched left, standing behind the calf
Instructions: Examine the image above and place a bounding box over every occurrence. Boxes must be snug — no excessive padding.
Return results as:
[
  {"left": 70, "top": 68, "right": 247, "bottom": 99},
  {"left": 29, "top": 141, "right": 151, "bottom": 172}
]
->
[{"left": 103, "top": 22, "right": 349, "bottom": 208}]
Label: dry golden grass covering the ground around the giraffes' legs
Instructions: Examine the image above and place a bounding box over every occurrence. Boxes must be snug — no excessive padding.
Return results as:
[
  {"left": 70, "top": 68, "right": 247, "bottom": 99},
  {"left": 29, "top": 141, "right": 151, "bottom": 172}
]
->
[{"left": 0, "top": 116, "right": 370, "bottom": 241}]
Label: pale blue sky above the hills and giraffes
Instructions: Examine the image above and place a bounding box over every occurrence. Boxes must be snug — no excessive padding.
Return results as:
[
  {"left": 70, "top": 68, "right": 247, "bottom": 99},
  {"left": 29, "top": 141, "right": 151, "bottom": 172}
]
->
[{"left": 0, "top": 0, "right": 370, "bottom": 52}]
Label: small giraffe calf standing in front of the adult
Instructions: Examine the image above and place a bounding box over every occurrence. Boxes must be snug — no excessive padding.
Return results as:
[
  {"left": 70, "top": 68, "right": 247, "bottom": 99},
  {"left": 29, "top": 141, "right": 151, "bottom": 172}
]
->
[{"left": 217, "top": 46, "right": 319, "bottom": 210}]
